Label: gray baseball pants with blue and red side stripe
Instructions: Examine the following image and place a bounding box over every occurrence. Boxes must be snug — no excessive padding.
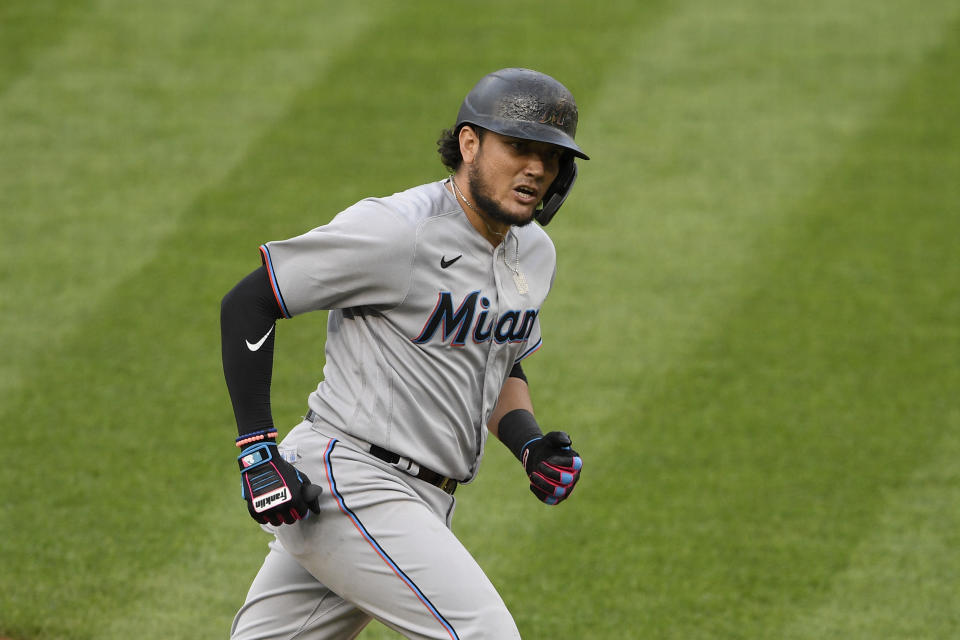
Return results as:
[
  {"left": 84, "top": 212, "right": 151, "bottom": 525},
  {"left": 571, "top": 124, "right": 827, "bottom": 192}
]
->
[{"left": 231, "top": 421, "right": 520, "bottom": 640}]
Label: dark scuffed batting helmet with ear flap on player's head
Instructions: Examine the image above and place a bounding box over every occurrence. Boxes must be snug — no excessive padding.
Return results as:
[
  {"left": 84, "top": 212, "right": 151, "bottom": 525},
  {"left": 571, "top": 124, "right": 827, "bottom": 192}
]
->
[{"left": 455, "top": 68, "right": 590, "bottom": 226}]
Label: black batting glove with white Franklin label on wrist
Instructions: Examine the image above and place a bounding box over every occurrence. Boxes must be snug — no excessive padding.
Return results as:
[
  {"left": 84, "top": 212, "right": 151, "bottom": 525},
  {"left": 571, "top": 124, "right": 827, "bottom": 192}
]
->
[{"left": 237, "top": 440, "right": 322, "bottom": 526}]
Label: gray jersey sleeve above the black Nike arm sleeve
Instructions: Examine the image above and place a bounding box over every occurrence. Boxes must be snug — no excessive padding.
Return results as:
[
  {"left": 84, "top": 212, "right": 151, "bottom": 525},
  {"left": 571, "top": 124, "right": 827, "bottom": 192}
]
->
[{"left": 260, "top": 199, "right": 416, "bottom": 318}]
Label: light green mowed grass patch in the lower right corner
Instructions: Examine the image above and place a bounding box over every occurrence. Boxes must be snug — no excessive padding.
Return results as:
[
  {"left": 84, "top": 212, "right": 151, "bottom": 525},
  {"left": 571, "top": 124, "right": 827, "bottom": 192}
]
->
[{"left": 779, "top": 411, "right": 960, "bottom": 640}]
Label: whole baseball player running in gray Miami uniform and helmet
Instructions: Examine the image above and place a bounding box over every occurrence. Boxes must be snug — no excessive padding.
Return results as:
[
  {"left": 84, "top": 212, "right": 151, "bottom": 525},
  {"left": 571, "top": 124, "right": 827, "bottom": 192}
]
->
[{"left": 221, "top": 69, "right": 588, "bottom": 640}]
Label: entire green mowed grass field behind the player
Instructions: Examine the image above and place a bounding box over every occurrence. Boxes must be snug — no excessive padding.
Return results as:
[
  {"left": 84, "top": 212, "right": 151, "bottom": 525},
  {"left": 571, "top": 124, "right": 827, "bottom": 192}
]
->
[{"left": 0, "top": 0, "right": 960, "bottom": 640}]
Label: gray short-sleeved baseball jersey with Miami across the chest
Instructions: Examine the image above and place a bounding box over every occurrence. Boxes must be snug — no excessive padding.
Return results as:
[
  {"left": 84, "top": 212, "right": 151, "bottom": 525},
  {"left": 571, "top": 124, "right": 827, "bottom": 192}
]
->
[{"left": 261, "top": 180, "right": 556, "bottom": 481}]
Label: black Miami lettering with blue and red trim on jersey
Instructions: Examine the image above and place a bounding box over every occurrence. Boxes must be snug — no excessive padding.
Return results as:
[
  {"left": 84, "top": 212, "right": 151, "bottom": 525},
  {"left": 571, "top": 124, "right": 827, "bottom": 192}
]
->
[{"left": 413, "top": 291, "right": 540, "bottom": 347}]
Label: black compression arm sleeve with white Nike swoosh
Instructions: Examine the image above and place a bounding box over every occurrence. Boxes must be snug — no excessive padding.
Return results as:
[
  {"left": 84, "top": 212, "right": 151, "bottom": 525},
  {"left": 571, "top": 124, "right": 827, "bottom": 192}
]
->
[{"left": 220, "top": 267, "right": 283, "bottom": 435}]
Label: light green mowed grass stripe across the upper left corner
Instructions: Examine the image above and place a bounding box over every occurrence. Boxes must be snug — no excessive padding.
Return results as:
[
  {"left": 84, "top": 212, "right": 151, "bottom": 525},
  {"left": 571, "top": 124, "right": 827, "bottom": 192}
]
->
[{"left": 0, "top": 0, "right": 378, "bottom": 395}]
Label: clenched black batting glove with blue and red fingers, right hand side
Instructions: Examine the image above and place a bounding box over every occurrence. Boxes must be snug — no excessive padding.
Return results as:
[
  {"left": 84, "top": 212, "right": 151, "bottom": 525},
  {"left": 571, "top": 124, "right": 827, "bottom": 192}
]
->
[{"left": 521, "top": 431, "right": 583, "bottom": 505}]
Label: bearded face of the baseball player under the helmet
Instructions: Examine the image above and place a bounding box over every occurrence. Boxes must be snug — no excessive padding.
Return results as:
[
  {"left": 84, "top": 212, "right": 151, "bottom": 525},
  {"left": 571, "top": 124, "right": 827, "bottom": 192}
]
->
[{"left": 467, "top": 131, "right": 563, "bottom": 226}]
